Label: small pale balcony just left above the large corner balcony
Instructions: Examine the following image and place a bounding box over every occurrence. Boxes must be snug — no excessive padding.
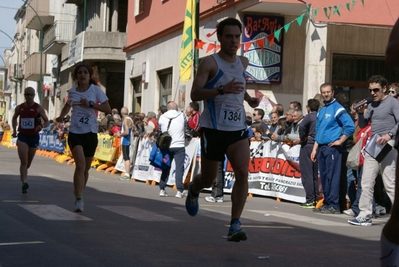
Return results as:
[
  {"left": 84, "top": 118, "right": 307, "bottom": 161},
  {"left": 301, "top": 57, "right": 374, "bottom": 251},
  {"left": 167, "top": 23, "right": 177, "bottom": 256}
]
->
[{"left": 43, "top": 21, "right": 75, "bottom": 55}]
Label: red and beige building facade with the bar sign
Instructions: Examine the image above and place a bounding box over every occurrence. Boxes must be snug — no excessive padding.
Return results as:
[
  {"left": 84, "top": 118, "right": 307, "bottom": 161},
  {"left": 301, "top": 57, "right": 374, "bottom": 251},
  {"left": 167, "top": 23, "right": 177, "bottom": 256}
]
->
[{"left": 124, "top": 0, "right": 399, "bottom": 112}]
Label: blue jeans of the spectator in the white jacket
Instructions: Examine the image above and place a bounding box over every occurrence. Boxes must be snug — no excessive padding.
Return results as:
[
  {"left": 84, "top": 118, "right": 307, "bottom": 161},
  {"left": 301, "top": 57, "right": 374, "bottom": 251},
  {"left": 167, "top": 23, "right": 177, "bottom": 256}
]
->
[{"left": 159, "top": 147, "right": 186, "bottom": 192}]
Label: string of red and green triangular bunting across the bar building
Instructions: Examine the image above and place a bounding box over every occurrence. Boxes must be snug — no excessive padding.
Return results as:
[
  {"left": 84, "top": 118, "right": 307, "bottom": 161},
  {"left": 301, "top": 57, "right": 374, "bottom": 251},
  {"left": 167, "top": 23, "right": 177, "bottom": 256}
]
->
[{"left": 194, "top": 0, "right": 364, "bottom": 54}]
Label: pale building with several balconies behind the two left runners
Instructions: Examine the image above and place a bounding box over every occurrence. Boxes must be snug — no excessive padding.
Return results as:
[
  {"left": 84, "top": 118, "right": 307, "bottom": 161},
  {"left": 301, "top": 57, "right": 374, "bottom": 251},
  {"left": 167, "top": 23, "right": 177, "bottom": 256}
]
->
[{"left": 6, "top": 0, "right": 127, "bottom": 119}]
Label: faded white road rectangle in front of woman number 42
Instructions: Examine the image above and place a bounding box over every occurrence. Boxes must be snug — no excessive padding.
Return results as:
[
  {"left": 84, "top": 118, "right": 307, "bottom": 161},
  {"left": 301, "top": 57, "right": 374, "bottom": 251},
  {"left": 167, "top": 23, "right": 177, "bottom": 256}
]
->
[{"left": 19, "top": 204, "right": 91, "bottom": 221}]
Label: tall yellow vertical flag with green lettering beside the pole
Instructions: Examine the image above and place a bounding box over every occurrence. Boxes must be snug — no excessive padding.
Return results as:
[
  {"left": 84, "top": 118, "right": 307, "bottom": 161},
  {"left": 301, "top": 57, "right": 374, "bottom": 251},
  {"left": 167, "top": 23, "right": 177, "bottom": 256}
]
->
[{"left": 180, "top": 0, "right": 197, "bottom": 83}]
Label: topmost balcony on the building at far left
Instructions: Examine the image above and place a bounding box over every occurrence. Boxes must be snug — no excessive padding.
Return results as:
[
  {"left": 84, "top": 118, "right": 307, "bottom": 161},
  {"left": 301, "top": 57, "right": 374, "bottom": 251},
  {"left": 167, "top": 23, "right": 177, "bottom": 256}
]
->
[{"left": 26, "top": 0, "right": 54, "bottom": 31}]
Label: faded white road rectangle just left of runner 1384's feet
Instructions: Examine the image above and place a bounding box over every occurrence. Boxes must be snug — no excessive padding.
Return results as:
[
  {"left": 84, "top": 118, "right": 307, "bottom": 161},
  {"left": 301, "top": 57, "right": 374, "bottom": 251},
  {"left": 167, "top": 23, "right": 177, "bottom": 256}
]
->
[{"left": 99, "top": 206, "right": 180, "bottom": 222}]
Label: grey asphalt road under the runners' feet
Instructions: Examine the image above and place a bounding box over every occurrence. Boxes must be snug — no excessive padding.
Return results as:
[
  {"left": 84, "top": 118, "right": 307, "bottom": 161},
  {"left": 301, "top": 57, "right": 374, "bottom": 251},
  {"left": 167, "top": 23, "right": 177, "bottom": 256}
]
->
[{"left": 0, "top": 145, "right": 387, "bottom": 267}]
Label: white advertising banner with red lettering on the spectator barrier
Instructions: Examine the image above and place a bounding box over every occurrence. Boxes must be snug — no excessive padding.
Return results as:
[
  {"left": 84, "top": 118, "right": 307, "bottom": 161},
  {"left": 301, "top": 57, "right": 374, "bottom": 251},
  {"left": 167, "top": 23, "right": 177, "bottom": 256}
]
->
[{"left": 132, "top": 138, "right": 305, "bottom": 203}]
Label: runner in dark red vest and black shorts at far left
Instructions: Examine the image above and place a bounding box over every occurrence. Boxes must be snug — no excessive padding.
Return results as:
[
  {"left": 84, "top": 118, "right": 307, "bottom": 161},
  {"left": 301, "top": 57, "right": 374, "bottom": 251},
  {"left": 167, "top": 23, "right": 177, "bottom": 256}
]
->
[{"left": 12, "top": 87, "right": 50, "bottom": 194}]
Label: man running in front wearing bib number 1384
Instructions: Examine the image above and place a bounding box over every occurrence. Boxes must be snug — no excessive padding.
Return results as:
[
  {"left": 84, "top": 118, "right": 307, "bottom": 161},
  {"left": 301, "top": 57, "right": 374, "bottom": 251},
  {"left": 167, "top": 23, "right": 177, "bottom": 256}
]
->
[{"left": 186, "top": 18, "right": 262, "bottom": 242}]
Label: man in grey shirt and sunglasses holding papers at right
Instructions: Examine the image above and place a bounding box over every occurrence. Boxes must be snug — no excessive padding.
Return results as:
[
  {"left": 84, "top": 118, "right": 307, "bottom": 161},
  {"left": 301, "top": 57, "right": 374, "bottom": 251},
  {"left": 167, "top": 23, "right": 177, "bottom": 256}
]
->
[{"left": 348, "top": 75, "right": 399, "bottom": 226}]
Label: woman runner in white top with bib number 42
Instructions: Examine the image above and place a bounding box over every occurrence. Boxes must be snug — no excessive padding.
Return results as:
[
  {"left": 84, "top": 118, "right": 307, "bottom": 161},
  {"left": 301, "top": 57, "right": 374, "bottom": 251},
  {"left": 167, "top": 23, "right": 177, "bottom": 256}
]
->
[{"left": 56, "top": 62, "right": 111, "bottom": 212}]
